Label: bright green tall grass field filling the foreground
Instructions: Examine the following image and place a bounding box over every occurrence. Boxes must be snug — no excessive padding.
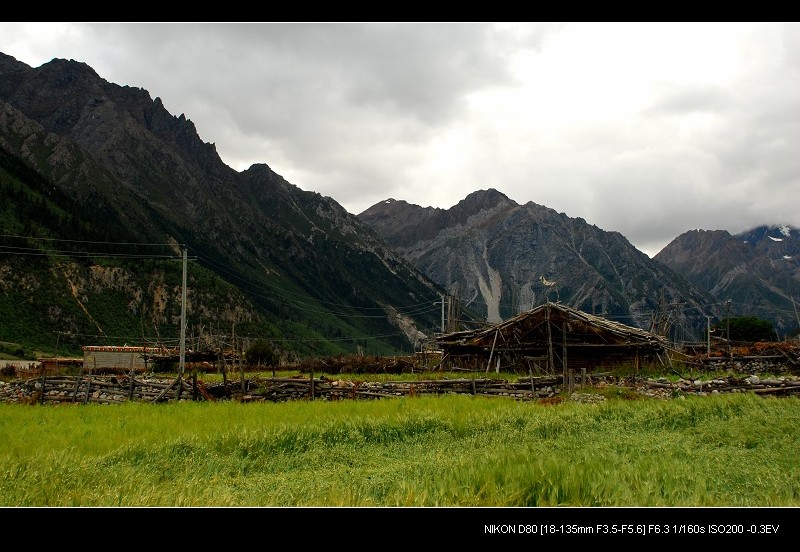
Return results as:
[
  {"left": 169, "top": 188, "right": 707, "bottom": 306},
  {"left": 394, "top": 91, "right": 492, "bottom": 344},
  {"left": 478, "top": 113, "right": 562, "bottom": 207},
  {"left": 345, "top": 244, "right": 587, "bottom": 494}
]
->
[{"left": 0, "top": 394, "right": 800, "bottom": 506}]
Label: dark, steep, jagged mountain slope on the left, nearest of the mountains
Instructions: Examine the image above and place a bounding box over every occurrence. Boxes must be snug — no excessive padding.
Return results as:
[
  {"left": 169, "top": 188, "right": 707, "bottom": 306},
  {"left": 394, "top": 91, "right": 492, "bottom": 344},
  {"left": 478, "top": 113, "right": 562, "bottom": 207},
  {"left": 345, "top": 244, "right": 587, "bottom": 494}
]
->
[{"left": 0, "top": 50, "right": 440, "bottom": 353}]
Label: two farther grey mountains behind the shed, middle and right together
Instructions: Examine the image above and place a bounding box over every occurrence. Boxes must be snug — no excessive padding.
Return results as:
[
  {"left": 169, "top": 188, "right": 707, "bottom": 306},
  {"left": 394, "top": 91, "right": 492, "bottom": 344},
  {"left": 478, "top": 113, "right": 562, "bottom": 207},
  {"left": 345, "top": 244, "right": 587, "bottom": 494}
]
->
[{"left": 359, "top": 189, "right": 800, "bottom": 342}]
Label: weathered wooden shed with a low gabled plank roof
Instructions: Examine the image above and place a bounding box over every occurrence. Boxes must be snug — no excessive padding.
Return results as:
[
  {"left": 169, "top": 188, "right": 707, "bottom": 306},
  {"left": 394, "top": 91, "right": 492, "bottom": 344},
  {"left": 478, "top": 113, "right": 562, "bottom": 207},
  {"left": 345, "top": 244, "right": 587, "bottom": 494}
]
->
[{"left": 435, "top": 302, "right": 669, "bottom": 375}]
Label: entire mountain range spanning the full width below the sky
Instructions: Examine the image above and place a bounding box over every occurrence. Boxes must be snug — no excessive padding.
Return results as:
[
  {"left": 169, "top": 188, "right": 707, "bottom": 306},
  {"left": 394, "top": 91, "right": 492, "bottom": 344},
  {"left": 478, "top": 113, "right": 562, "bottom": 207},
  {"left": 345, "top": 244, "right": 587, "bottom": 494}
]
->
[{"left": 0, "top": 53, "right": 800, "bottom": 359}]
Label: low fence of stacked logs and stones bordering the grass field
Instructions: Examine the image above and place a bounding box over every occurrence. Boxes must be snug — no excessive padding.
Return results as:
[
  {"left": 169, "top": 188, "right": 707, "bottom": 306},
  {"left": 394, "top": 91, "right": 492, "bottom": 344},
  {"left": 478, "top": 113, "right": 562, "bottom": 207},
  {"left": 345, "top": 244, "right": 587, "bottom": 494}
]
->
[{"left": 0, "top": 375, "right": 800, "bottom": 404}]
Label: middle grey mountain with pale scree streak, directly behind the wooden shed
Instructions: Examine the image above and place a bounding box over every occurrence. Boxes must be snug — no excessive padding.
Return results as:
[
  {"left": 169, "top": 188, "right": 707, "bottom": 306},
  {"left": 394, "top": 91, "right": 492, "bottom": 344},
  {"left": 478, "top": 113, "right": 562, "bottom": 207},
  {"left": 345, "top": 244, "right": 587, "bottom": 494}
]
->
[{"left": 358, "top": 189, "right": 715, "bottom": 335}]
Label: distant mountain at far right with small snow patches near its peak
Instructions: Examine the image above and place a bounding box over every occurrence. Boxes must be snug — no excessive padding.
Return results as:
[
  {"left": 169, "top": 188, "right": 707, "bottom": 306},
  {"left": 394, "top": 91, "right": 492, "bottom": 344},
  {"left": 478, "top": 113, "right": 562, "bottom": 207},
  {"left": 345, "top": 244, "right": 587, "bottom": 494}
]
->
[{"left": 654, "top": 225, "right": 800, "bottom": 336}]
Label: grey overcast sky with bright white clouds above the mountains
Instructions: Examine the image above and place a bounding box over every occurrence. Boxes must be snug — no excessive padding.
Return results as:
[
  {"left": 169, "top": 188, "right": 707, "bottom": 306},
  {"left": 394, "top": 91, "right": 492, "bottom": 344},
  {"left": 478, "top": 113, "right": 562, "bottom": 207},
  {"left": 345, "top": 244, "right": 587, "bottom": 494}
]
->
[{"left": 0, "top": 22, "right": 800, "bottom": 256}]
